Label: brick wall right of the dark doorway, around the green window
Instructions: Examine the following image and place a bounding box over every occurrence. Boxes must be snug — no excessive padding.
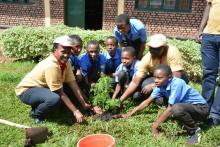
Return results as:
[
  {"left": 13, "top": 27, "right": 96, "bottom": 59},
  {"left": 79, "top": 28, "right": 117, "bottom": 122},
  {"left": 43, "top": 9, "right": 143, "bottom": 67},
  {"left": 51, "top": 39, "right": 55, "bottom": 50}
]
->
[{"left": 103, "top": 0, "right": 205, "bottom": 38}]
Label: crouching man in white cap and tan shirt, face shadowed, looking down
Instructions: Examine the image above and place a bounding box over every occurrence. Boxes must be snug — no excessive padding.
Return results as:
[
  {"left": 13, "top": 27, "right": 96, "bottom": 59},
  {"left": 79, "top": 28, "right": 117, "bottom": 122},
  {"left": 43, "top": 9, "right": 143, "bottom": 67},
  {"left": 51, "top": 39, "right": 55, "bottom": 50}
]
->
[{"left": 120, "top": 34, "right": 188, "bottom": 103}]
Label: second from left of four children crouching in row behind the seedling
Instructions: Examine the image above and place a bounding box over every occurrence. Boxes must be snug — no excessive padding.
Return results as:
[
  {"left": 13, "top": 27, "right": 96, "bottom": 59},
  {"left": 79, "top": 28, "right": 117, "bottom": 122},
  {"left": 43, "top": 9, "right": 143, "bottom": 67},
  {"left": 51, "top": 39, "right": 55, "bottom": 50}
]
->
[{"left": 79, "top": 40, "right": 106, "bottom": 89}]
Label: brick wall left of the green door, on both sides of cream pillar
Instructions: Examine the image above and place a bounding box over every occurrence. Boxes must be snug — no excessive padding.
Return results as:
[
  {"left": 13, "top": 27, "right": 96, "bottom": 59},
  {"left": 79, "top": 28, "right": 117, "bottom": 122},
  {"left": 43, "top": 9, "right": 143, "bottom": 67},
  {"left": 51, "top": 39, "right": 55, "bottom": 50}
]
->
[{"left": 0, "top": 0, "right": 64, "bottom": 26}]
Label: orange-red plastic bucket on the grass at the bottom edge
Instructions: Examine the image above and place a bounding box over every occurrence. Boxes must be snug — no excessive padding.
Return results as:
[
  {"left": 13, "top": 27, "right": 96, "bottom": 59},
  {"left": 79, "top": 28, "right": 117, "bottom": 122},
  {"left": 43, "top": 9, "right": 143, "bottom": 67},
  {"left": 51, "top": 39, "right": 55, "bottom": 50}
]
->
[{"left": 77, "top": 134, "right": 115, "bottom": 147}]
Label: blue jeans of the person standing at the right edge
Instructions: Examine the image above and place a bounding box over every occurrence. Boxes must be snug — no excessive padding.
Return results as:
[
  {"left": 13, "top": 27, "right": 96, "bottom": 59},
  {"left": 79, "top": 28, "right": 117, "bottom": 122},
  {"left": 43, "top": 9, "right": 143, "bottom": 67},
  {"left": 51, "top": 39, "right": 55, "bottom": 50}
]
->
[{"left": 202, "top": 34, "right": 220, "bottom": 119}]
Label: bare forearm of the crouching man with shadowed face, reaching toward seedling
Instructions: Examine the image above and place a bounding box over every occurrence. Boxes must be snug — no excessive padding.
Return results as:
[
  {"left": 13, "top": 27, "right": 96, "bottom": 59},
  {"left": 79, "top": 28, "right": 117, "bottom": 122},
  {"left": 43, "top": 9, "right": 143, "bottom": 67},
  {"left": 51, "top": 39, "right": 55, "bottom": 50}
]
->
[{"left": 120, "top": 76, "right": 142, "bottom": 103}]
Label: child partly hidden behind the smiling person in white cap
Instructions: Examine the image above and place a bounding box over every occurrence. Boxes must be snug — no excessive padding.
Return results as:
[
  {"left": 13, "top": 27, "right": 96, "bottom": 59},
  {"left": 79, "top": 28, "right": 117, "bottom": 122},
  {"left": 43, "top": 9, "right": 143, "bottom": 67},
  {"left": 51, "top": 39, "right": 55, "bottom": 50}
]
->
[{"left": 69, "top": 35, "right": 83, "bottom": 82}]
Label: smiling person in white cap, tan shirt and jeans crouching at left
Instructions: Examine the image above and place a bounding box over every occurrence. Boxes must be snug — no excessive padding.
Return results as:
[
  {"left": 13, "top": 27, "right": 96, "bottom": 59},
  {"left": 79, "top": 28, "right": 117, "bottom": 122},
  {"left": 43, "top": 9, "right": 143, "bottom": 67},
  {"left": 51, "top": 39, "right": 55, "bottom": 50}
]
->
[{"left": 15, "top": 36, "right": 90, "bottom": 123}]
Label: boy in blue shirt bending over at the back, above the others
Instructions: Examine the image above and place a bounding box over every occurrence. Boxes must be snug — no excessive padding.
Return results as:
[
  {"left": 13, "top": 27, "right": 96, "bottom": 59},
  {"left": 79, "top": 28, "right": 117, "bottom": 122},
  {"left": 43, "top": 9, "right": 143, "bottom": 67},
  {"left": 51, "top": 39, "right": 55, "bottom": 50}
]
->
[{"left": 114, "top": 14, "right": 147, "bottom": 60}]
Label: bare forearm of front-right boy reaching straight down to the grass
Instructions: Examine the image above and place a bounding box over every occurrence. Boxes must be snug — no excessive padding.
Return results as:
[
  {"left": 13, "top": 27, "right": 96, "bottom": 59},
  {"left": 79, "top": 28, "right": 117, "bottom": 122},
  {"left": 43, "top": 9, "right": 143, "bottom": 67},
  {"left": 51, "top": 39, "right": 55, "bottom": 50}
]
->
[{"left": 151, "top": 104, "right": 172, "bottom": 138}]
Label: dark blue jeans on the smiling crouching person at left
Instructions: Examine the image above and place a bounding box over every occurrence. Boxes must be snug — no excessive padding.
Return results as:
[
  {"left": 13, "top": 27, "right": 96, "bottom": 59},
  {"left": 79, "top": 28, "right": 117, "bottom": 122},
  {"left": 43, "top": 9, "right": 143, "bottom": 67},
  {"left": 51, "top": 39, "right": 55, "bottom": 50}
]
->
[{"left": 19, "top": 87, "right": 60, "bottom": 117}]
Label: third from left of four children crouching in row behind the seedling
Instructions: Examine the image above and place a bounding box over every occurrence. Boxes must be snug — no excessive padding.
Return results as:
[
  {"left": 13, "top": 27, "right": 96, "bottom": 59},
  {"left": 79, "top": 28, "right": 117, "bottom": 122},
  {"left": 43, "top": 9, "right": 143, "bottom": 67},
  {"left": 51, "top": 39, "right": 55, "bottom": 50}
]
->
[{"left": 102, "top": 36, "right": 121, "bottom": 77}]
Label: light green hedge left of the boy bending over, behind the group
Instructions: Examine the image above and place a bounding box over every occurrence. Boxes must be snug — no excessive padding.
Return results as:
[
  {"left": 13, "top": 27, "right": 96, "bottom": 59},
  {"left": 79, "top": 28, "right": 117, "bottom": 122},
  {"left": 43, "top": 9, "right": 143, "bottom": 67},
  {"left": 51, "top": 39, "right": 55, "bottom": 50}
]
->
[{"left": 0, "top": 25, "right": 112, "bottom": 60}]
